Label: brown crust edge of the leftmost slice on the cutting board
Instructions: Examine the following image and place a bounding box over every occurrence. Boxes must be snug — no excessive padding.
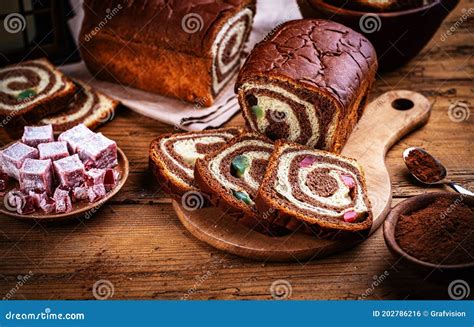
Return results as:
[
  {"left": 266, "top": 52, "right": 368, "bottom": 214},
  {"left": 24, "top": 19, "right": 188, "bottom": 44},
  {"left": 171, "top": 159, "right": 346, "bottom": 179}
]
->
[{"left": 149, "top": 127, "right": 243, "bottom": 199}]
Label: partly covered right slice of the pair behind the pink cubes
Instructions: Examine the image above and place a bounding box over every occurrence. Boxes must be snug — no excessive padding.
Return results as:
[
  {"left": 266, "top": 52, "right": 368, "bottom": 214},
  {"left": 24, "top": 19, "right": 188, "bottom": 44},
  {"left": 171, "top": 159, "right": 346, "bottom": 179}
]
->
[{"left": 39, "top": 80, "right": 118, "bottom": 132}]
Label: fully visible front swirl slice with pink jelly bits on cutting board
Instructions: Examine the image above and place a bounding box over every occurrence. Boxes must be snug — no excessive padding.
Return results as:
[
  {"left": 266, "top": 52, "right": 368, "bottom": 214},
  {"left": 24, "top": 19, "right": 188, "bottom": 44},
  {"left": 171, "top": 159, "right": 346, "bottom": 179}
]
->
[{"left": 255, "top": 141, "right": 372, "bottom": 237}]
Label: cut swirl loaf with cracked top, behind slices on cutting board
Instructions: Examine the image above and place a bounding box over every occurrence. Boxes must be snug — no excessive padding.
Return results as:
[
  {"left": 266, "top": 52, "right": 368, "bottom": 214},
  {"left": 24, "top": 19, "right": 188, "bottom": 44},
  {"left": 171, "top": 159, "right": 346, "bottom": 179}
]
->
[{"left": 235, "top": 19, "right": 377, "bottom": 153}]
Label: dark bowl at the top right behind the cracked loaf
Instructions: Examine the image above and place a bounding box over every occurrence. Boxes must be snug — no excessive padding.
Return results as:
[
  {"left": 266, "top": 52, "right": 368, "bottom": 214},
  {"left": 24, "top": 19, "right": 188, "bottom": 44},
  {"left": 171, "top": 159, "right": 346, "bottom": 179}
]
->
[{"left": 297, "top": 0, "right": 459, "bottom": 71}]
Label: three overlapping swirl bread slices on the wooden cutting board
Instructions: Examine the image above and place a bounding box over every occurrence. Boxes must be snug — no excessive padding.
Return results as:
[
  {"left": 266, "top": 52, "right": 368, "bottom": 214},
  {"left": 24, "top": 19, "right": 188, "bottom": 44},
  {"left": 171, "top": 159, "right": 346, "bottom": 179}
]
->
[{"left": 149, "top": 128, "right": 372, "bottom": 238}]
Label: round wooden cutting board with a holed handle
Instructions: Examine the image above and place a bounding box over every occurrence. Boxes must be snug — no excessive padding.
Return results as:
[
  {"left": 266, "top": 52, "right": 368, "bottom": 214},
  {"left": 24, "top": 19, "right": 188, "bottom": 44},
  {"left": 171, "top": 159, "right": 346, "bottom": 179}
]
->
[{"left": 173, "top": 90, "right": 431, "bottom": 261}]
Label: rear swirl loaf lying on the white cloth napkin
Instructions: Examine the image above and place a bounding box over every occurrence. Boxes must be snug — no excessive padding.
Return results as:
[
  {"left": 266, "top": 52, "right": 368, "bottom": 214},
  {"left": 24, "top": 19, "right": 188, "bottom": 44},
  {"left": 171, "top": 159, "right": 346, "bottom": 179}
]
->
[{"left": 80, "top": 0, "right": 255, "bottom": 106}]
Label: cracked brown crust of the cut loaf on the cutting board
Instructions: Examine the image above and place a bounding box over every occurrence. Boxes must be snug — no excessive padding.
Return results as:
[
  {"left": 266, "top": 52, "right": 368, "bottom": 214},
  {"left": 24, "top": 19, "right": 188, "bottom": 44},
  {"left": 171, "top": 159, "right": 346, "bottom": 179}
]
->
[{"left": 235, "top": 19, "right": 378, "bottom": 153}]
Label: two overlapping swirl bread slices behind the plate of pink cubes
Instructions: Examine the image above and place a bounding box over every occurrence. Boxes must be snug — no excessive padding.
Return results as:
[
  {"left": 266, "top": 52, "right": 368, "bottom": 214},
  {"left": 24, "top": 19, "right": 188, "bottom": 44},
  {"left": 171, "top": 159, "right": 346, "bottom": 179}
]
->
[{"left": 0, "top": 59, "right": 118, "bottom": 137}]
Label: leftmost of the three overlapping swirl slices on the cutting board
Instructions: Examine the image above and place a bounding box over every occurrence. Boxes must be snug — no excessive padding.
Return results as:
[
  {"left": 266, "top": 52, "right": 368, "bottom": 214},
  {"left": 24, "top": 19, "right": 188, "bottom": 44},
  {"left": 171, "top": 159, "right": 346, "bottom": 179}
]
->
[{"left": 149, "top": 128, "right": 243, "bottom": 197}]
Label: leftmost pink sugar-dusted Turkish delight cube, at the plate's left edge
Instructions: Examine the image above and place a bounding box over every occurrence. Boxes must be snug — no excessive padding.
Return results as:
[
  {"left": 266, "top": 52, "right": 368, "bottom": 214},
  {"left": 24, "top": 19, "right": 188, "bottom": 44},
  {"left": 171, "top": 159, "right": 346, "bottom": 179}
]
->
[{"left": 0, "top": 142, "right": 38, "bottom": 180}]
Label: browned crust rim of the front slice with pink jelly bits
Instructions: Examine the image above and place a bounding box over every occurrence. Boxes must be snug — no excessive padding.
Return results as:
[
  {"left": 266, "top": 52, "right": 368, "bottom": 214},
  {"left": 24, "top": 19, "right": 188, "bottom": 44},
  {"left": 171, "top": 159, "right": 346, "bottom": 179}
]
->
[{"left": 255, "top": 140, "right": 373, "bottom": 238}]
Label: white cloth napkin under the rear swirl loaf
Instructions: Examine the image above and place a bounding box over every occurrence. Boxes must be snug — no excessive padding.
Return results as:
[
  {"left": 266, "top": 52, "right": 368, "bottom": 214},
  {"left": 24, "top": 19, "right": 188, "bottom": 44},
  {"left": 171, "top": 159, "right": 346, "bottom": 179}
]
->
[{"left": 60, "top": 0, "right": 301, "bottom": 131}]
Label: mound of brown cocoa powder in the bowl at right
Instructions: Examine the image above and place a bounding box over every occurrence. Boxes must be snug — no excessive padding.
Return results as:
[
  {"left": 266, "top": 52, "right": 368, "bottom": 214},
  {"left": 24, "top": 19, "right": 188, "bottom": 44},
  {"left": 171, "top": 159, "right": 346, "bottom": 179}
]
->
[{"left": 395, "top": 195, "right": 474, "bottom": 265}]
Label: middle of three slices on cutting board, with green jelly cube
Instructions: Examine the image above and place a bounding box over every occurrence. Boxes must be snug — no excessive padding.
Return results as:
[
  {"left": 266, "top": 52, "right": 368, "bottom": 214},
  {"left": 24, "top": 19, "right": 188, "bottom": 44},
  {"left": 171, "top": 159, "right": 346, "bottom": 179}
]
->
[{"left": 194, "top": 133, "right": 280, "bottom": 233}]
